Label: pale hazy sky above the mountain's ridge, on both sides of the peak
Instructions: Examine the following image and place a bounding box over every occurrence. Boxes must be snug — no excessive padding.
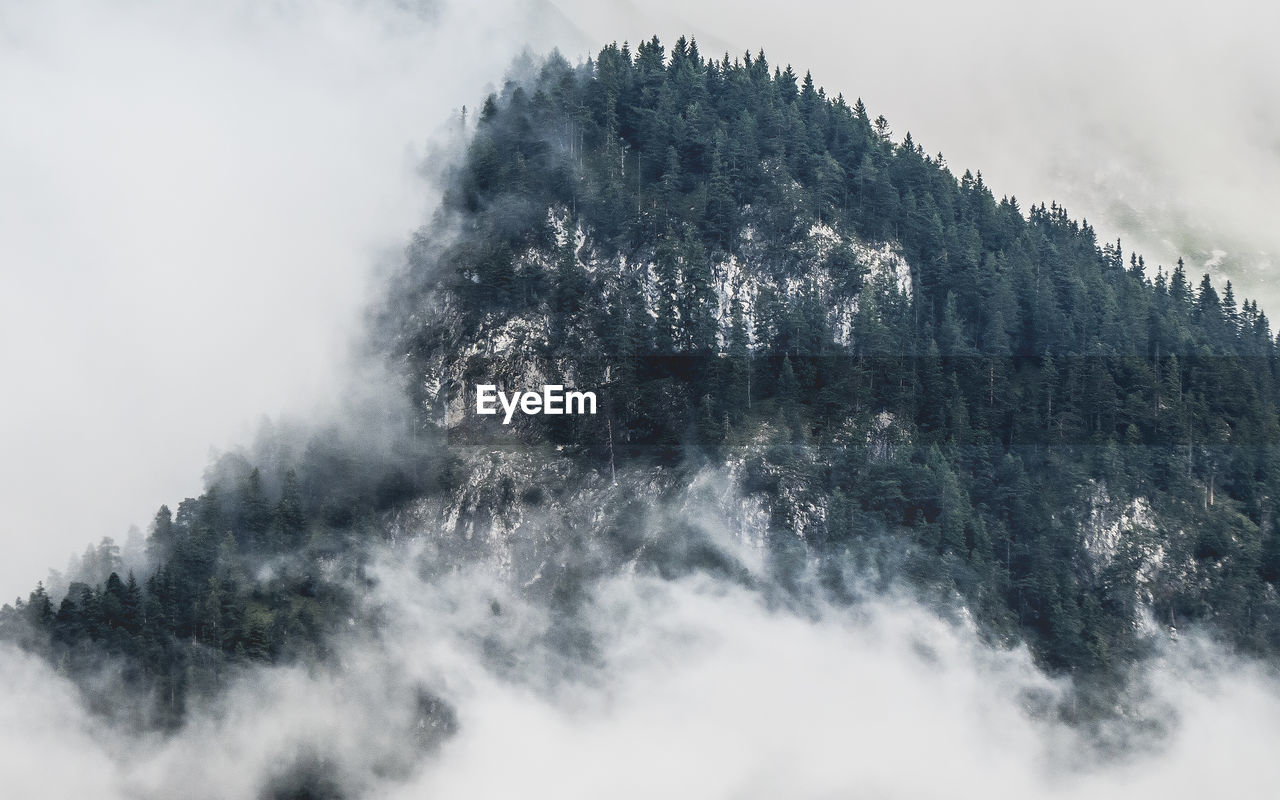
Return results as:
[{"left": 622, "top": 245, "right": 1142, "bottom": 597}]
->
[{"left": 0, "top": 0, "right": 1280, "bottom": 596}]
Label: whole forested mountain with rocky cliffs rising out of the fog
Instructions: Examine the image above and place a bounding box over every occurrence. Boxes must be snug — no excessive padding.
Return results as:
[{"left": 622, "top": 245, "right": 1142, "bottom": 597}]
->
[{"left": 0, "top": 31, "right": 1280, "bottom": 762}]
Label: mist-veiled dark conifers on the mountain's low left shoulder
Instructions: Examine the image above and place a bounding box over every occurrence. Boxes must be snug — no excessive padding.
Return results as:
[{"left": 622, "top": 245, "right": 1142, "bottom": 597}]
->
[{"left": 0, "top": 422, "right": 448, "bottom": 727}]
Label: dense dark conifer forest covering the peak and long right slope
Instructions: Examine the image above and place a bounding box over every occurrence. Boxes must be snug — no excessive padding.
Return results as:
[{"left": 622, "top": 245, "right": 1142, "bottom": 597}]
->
[{"left": 378, "top": 38, "right": 1280, "bottom": 668}]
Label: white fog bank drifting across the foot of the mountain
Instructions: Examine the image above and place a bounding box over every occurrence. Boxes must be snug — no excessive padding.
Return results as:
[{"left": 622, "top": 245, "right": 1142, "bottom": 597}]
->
[{"left": 0, "top": 532, "right": 1280, "bottom": 800}]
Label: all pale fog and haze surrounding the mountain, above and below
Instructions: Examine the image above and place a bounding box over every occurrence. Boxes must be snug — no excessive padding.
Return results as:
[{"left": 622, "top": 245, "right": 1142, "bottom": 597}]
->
[{"left": 0, "top": 0, "right": 1280, "bottom": 799}]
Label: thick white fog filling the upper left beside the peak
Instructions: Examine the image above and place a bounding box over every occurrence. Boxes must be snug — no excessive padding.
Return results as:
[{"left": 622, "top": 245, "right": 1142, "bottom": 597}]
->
[{"left": 0, "top": 0, "right": 586, "bottom": 586}]
